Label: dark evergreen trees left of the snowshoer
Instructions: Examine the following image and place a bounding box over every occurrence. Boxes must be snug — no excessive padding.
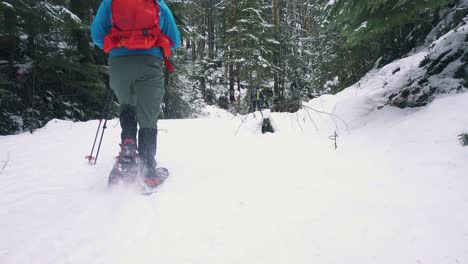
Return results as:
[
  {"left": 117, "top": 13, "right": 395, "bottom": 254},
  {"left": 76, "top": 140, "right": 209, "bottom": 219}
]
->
[{"left": 0, "top": 0, "right": 107, "bottom": 134}]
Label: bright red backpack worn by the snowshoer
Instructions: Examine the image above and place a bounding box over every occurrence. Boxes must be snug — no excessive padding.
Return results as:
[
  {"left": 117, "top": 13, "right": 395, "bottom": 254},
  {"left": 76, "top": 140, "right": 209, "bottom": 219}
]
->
[{"left": 103, "top": 0, "right": 174, "bottom": 71}]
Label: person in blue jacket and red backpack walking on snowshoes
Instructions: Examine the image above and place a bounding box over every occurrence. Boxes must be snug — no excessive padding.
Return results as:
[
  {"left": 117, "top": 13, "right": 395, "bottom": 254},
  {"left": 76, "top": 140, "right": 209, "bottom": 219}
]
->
[{"left": 91, "top": 0, "right": 180, "bottom": 189}]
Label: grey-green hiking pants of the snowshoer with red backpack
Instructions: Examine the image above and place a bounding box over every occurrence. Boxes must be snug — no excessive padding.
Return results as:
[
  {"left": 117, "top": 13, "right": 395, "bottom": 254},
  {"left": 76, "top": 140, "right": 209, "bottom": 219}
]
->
[{"left": 109, "top": 55, "right": 164, "bottom": 128}]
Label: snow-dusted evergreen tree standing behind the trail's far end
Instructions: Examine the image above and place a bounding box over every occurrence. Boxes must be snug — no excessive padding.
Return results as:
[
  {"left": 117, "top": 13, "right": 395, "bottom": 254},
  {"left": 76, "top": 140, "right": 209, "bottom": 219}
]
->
[{"left": 224, "top": 1, "right": 279, "bottom": 104}]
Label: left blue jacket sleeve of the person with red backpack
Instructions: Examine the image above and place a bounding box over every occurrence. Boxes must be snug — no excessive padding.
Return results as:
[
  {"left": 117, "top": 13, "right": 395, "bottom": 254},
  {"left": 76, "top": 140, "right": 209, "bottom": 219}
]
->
[{"left": 91, "top": 0, "right": 112, "bottom": 49}]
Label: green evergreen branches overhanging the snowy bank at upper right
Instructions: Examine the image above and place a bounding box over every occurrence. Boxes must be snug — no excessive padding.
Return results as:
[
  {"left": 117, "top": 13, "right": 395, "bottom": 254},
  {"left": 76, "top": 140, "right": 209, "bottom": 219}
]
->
[{"left": 318, "top": 0, "right": 454, "bottom": 91}]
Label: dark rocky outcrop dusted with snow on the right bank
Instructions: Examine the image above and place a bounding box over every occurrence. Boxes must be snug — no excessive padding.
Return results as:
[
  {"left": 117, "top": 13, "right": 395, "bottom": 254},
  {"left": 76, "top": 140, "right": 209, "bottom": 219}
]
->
[{"left": 386, "top": 0, "right": 468, "bottom": 108}]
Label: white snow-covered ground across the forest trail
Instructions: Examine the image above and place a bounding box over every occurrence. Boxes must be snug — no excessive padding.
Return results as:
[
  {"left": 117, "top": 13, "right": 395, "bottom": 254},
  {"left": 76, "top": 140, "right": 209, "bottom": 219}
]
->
[{"left": 0, "top": 79, "right": 468, "bottom": 264}]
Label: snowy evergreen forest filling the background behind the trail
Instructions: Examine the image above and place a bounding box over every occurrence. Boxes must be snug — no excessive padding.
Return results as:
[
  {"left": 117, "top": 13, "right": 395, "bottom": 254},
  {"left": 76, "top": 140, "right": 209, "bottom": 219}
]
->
[{"left": 0, "top": 0, "right": 468, "bottom": 135}]
